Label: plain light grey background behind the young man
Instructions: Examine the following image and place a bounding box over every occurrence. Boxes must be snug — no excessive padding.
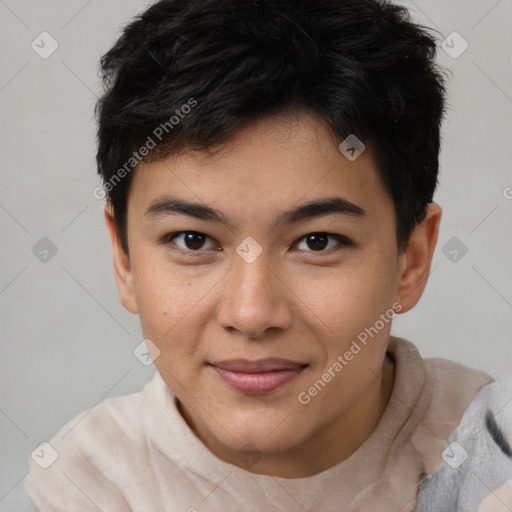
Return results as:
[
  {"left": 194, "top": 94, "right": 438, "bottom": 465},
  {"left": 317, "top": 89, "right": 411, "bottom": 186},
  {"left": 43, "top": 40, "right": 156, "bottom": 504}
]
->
[{"left": 0, "top": 0, "right": 512, "bottom": 511}]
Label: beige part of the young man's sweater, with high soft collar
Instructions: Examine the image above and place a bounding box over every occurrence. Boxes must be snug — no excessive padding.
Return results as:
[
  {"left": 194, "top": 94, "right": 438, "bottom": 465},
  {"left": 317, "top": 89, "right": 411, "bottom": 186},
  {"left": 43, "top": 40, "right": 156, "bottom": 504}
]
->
[{"left": 25, "top": 337, "right": 493, "bottom": 512}]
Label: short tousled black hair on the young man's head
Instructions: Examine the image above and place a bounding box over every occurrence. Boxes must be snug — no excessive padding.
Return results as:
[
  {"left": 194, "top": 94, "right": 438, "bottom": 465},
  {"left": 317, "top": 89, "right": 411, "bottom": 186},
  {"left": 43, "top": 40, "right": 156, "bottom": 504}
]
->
[{"left": 96, "top": 0, "right": 446, "bottom": 254}]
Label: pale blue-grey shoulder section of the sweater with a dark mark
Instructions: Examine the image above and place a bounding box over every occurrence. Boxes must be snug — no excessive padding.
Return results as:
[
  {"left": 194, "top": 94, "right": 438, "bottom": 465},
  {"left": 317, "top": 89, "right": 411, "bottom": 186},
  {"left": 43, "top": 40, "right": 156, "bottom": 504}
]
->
[{"left": 416, "top": 378, "right": 512, "bottom": 512}]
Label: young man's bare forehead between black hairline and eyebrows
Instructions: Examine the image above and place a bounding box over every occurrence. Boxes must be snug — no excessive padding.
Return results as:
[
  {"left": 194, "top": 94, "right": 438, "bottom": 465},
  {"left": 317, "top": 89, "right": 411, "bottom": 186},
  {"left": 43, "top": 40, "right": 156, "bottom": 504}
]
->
[{"left": 128, "top": 114, "right": 392, "bottom": 229}]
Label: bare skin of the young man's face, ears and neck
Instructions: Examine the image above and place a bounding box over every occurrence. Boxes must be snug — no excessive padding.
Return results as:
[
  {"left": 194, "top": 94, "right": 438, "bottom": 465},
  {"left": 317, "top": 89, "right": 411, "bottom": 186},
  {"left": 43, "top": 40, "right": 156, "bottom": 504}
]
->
[{"left": 105, "top": 114, "right": 442, "bottom": 478}]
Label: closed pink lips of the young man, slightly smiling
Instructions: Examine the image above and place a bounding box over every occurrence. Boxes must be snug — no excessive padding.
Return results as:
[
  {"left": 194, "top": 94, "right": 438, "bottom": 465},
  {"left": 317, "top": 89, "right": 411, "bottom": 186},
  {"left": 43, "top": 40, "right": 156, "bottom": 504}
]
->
[{"left": 208, "top": 358, "right": 309, "bottom": 394}]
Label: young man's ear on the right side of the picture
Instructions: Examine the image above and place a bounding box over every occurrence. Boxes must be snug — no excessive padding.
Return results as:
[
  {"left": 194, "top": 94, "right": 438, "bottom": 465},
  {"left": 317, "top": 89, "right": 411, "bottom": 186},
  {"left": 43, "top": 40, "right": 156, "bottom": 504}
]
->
[{"left": 396, "top": 203, "right": 442, "bottom": 313}]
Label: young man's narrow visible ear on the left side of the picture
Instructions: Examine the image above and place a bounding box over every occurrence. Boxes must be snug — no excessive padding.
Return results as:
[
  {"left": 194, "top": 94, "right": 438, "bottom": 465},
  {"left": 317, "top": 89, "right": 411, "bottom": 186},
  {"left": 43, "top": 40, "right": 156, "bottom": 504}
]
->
[{"left": 103, "top": 203, "right": 139, "bottom": 314}]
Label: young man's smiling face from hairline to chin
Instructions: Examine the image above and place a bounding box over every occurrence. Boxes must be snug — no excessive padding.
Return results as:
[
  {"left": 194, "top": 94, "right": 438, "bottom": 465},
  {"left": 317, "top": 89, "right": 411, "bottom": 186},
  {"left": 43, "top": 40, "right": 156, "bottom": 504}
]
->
[{"left": 106, "top": 115, "right": 434, "bottom": 464}]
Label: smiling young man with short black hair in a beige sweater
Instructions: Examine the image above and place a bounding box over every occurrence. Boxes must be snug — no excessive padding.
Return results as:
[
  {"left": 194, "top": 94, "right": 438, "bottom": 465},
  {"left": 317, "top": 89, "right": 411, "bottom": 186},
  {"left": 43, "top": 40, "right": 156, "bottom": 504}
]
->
[{"left": 26, "top": 0, "right": 512, "bottom": 512}]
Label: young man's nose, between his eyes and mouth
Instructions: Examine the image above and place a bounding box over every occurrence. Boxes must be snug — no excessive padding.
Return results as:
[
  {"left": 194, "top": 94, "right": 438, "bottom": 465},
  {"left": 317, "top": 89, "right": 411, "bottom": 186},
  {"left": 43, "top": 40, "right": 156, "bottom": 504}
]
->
[{"left": 217, "top": 255, "right": 293, "bottom": 339}]
